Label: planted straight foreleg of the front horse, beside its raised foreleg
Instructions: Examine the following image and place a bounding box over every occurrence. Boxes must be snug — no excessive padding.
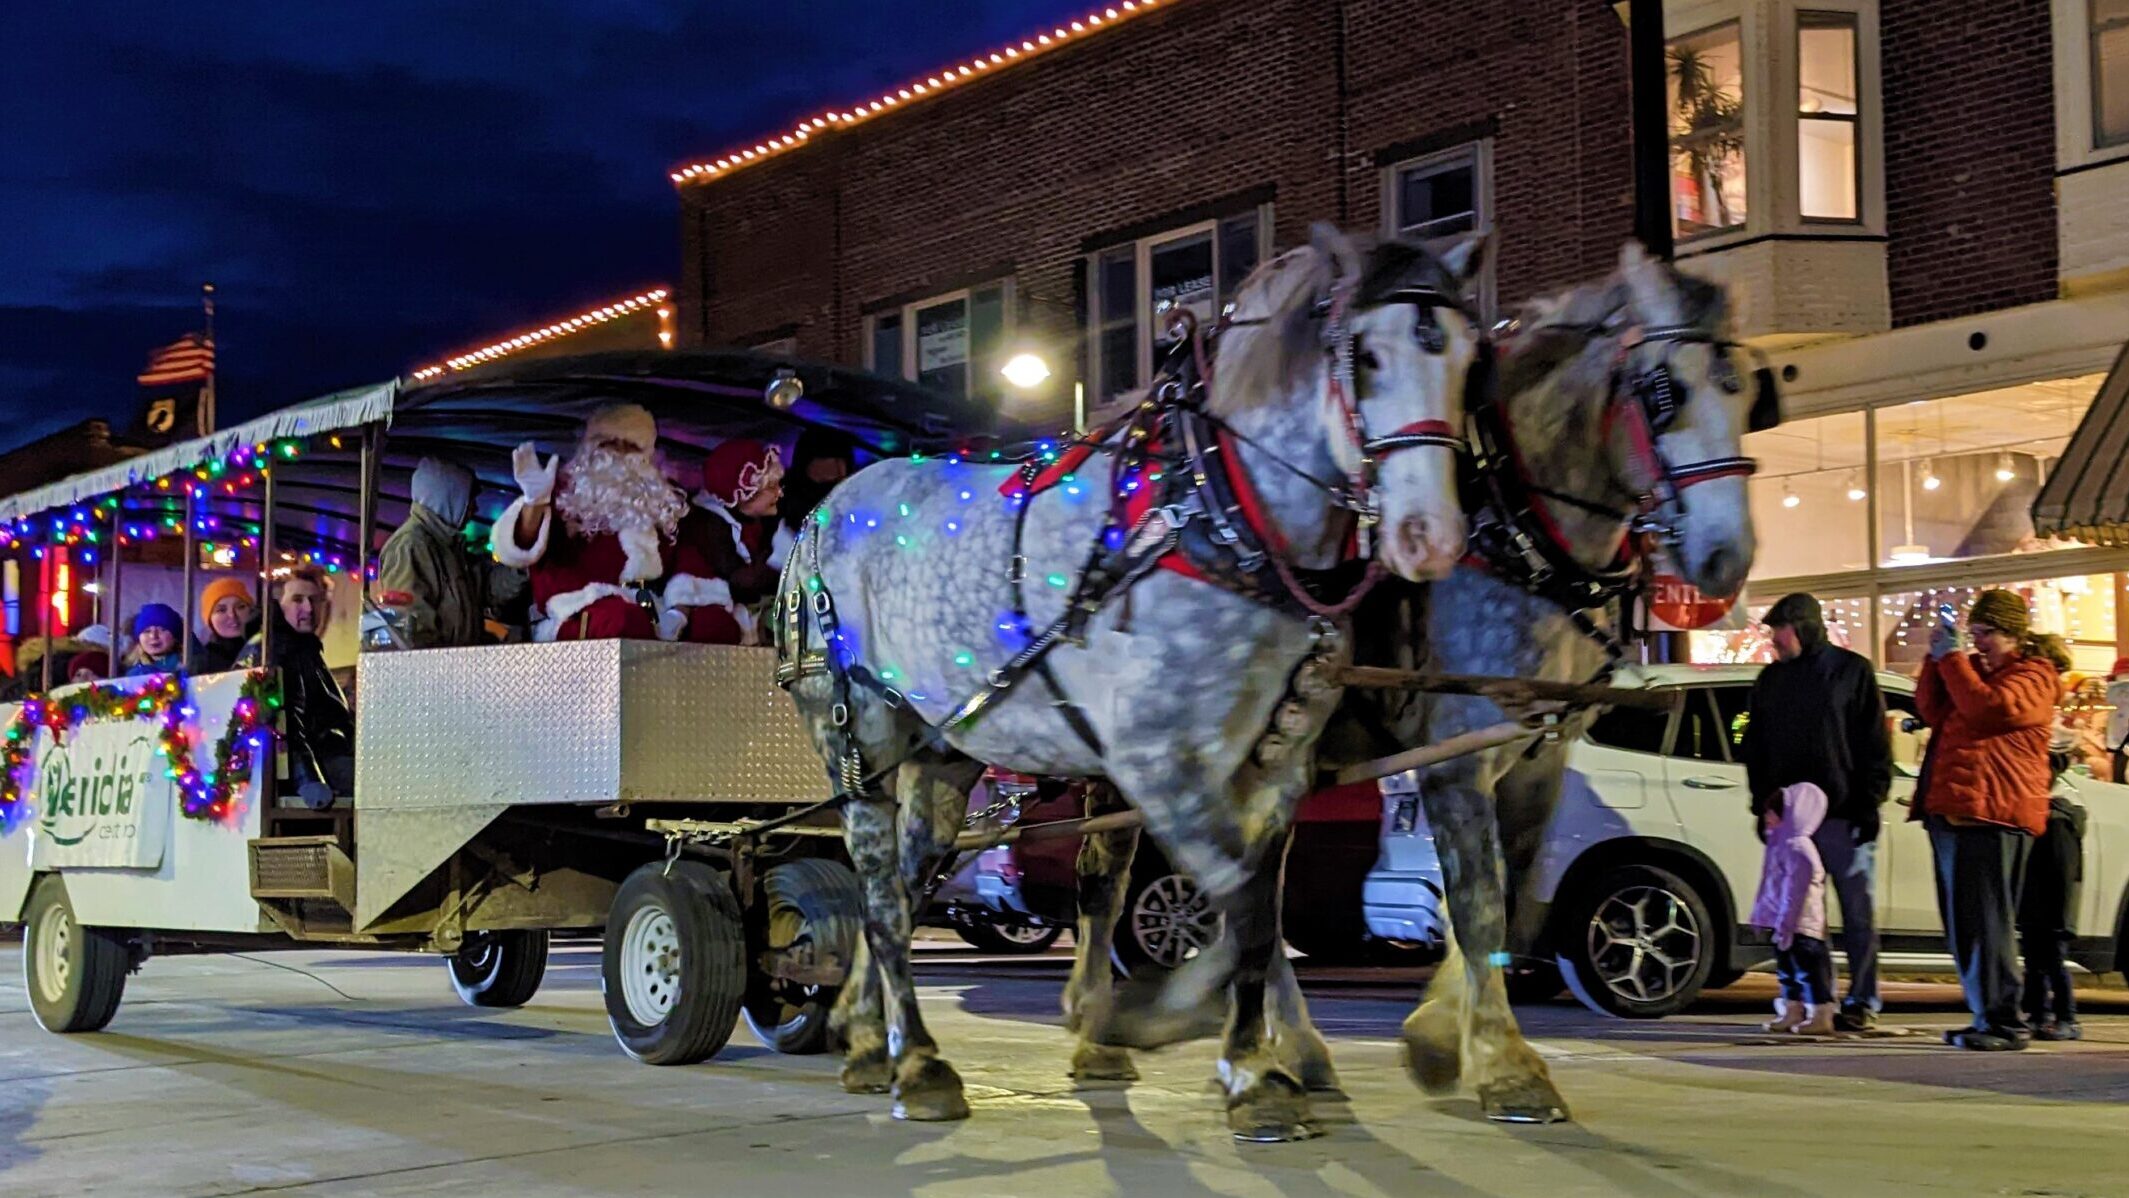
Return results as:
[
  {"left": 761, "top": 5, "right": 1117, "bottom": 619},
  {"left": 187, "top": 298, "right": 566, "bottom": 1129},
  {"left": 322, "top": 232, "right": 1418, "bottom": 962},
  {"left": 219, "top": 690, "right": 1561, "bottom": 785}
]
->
[{"left": 1220, "top": 842, "right": 1318, "bottom": 1143}]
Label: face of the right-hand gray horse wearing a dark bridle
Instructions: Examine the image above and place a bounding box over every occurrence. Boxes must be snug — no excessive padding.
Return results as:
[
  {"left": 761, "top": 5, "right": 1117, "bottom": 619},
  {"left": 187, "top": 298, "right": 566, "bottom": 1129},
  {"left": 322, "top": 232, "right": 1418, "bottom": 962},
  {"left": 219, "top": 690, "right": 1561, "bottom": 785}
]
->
[{"left": 1614, "top": 243, "right": 1773, "bottom": 596}]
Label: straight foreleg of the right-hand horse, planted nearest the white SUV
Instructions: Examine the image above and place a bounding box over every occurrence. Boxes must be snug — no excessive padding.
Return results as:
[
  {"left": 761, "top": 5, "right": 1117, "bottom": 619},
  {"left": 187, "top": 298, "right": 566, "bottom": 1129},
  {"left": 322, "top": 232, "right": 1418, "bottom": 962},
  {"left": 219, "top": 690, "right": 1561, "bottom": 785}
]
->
[{"left": 1405, "top": 755, "right": 1567, "bottom": 1124}]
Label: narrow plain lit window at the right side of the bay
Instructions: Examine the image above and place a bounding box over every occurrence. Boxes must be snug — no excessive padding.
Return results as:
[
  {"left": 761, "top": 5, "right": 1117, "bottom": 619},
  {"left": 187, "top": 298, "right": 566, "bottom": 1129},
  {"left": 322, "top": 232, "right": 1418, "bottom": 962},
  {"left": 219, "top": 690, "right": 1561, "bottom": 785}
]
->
[{"left": 1797, "top": 12, "right": 1865, "bottom": 221}]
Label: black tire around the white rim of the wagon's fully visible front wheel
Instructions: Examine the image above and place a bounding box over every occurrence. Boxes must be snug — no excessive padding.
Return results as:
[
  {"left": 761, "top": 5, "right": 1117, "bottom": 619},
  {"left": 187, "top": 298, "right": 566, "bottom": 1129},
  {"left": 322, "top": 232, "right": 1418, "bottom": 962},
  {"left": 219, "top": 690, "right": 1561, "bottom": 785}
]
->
[{"left": 598, "top": 862, "right": 747, "bottom": 1064}]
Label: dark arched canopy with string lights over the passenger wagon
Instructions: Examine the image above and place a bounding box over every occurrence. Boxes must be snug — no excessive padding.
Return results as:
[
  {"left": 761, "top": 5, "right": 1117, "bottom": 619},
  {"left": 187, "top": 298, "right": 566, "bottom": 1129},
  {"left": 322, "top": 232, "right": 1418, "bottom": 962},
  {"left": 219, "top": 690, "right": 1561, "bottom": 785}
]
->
[{"left": 0, "top": 349, "right": 1013, "bottom": 558}]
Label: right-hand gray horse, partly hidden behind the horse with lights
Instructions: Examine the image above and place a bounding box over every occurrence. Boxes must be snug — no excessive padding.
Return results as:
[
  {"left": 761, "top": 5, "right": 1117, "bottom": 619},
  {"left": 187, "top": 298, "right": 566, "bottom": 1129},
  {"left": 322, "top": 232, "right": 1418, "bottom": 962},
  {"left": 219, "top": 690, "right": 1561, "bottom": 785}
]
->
[{"left": 1065, "top": 245, "right": 1754, "bottom": 1138}]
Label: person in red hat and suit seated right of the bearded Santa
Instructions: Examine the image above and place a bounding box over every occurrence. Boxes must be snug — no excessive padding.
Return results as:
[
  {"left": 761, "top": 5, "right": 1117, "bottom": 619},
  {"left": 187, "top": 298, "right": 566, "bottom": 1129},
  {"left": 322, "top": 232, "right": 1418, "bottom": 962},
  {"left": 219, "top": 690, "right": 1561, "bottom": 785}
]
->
[{"left": 658, "top": 438, "right": 783, "bottom": 645}]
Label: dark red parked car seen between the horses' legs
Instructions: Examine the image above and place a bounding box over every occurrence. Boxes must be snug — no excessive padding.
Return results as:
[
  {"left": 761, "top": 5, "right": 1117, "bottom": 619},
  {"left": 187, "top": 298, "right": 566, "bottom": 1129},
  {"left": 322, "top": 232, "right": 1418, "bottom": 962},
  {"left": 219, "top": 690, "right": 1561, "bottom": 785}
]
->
[{"left": 964, "top": 783, "right": 1443, "bottom": 972}]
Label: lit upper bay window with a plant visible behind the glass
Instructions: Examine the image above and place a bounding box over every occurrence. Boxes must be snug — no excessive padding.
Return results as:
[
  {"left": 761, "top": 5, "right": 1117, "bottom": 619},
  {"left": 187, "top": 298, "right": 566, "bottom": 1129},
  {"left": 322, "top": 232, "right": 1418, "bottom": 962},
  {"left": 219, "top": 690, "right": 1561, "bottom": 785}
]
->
[{"left": 1667, "top": 21, "right": 1746, "bottom": 238}]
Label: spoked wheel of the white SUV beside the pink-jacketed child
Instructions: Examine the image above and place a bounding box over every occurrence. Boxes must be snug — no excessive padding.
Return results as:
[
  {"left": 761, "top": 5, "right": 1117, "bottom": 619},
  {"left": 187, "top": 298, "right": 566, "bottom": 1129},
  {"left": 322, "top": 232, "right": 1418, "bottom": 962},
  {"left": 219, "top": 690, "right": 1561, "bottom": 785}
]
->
[{"left": 1554, "top": 866, "right": 1716, "bottom": 1019}]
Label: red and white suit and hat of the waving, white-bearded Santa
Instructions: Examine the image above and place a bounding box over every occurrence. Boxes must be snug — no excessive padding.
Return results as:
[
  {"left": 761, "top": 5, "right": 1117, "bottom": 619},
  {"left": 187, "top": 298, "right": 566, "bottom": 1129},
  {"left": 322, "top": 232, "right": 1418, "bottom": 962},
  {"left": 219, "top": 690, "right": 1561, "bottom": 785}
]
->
[{"left": 494, "top": 404, "right": 675, "bottom": 640}]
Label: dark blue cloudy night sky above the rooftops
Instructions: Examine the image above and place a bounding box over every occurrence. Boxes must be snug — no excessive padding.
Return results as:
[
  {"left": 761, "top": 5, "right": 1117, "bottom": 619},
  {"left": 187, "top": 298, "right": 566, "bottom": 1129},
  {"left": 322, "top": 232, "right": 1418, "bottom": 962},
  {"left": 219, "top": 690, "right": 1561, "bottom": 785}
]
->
[{"left": 0, "top": 0, "right": 1090, "bottom": 449}]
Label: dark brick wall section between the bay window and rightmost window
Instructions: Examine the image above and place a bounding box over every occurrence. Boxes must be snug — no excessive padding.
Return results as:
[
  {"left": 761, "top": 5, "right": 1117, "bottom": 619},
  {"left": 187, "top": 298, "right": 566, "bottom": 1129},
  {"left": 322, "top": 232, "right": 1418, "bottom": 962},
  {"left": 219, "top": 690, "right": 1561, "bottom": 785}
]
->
[{"left": 1878, "top": 0, "right": 2059, "bottom": 326}]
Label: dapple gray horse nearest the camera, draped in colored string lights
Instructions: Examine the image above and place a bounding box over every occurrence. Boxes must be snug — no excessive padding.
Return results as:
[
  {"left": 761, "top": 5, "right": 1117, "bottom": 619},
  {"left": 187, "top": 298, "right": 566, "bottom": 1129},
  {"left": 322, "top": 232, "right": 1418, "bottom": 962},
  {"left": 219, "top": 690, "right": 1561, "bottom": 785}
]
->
[{"left": 779, "top": 232, "right": 1480, "bottom": 1119}]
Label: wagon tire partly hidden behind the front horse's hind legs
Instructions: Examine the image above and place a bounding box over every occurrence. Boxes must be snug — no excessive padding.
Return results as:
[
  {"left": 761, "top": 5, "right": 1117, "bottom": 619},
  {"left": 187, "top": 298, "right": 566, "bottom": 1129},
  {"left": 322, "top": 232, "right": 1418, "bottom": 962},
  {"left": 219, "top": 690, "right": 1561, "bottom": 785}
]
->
[{"left": 741, "top": 858, "right": 864, "bottom": 1055}]
